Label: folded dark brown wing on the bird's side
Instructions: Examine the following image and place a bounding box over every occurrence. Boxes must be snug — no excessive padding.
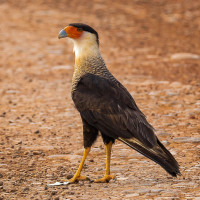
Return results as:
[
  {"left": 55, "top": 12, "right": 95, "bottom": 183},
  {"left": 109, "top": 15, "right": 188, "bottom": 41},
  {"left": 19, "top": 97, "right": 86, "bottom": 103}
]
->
[{"left": 72, "top": 74, "right": 157, "bottom": 147}]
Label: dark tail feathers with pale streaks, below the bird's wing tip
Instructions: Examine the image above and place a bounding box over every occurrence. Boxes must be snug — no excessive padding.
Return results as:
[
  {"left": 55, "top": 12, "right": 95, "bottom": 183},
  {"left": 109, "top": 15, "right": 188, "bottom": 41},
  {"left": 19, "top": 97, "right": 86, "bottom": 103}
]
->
[{"left": 118, "top": 138, "right": 181, "bottom": 177}]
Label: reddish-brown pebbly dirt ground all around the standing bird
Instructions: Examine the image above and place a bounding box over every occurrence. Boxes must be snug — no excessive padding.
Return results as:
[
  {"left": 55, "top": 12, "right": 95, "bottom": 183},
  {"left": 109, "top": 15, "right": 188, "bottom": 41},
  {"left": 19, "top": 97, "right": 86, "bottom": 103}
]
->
[{"left": 0, "top": 0, "right": 200, "bottom": 200}]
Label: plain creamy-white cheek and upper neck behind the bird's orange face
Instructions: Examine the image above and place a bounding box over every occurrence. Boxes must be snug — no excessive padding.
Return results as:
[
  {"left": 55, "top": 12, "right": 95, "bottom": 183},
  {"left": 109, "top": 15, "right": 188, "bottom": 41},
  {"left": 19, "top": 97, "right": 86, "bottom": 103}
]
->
[{"left": 73, "top": 32, "right": 100, "bottom": 60}]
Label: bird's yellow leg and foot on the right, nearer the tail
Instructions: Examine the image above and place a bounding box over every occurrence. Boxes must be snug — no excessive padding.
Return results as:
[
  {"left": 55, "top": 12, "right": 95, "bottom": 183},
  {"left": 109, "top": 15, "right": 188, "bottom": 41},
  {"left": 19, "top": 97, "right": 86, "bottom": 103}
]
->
[{"left": 94, "top": 142, "right": 115, "bottom": 183}]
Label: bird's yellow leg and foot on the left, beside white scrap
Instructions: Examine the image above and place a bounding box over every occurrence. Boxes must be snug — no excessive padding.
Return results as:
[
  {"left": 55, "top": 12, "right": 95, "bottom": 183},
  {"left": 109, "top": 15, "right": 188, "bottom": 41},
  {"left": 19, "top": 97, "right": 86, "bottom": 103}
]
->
[{"left": 69, "top": 147, "right": 91, "bottom": 183}]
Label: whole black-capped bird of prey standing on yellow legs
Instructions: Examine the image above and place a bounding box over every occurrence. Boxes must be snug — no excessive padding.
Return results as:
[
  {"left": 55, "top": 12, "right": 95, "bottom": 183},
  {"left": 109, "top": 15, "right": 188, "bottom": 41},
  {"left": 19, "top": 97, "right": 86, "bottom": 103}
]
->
[{"left": 58, "top": 23, "right": 180, "bottom": 183}]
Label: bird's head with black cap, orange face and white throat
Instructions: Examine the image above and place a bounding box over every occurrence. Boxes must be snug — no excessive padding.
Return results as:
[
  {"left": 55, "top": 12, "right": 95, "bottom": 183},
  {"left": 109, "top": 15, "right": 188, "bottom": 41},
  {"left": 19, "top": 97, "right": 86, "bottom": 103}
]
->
[{"left": 58, "top": 23, "right": 99, "bottom": 56}]
